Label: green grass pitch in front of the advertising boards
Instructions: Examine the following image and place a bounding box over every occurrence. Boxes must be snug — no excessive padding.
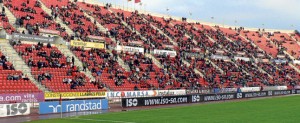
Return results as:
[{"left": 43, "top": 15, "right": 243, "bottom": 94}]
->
[{"left": 30, "top": 96, "right": 300, "bottom": 123}]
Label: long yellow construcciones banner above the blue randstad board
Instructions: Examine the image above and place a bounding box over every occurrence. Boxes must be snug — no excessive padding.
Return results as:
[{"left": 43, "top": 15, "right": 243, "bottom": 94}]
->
[{"left": 45, "top": 92, "right": 105, "bottom": 99}]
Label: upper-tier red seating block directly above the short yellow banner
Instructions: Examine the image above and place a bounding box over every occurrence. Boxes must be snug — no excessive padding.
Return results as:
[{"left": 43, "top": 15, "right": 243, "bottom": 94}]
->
[{"left": 41, "top": 0, "right": 108, "bottom": 41}]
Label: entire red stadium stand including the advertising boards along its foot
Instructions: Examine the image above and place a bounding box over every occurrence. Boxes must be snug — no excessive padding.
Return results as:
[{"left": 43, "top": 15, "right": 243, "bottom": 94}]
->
[{"left": 0, "top": 0, "right": 300, "bottom": 122}]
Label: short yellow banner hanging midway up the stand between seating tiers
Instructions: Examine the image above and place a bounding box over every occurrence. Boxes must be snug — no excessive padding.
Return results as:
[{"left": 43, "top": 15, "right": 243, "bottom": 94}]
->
[{"left": 71, "top": 40, "right": 105, "bottom": 49}]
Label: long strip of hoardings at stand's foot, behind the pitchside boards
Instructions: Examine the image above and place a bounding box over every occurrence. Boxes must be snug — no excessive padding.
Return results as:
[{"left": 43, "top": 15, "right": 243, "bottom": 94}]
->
[{"left": 0, "top": 86, "right": 290, "bottom": 101}]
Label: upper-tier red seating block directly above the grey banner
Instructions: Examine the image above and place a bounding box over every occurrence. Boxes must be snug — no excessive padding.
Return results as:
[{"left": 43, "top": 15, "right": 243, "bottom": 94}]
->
[{"left": 4, "top": 0, "right": 69, "bottom": 39}]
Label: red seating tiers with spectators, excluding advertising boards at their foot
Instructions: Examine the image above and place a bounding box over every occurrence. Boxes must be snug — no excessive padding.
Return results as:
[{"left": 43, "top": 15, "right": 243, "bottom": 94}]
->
[{"left": 0, "top": 0, "right": 300, "bottom": 93}]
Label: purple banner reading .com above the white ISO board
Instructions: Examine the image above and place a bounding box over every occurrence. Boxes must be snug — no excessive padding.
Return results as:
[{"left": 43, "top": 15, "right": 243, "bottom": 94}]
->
[{"left": 0, "top": 93, "right": 45, "bottom": 104}]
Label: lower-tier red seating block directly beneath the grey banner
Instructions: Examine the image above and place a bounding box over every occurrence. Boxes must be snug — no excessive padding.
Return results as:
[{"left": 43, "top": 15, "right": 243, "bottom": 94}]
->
[{"left": 14, "top": 43, "right": 99, "bottom": 92}]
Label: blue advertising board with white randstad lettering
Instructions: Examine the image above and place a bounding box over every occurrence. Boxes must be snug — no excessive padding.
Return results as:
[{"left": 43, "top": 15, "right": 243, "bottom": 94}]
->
[{"left": 39, "top": 99, "right": 108, "bottom": 114}]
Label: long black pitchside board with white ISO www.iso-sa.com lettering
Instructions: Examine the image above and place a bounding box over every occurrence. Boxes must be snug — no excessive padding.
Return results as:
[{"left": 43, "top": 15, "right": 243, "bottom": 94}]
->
[{"left": 122, "top": 90, "right": 300, "bottom": 108}]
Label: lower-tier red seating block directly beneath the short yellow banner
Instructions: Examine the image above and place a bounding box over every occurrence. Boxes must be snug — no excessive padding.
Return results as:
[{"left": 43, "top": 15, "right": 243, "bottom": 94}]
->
[{"left": 71, "top": 47, "right": 134, "bottom": 91}]
